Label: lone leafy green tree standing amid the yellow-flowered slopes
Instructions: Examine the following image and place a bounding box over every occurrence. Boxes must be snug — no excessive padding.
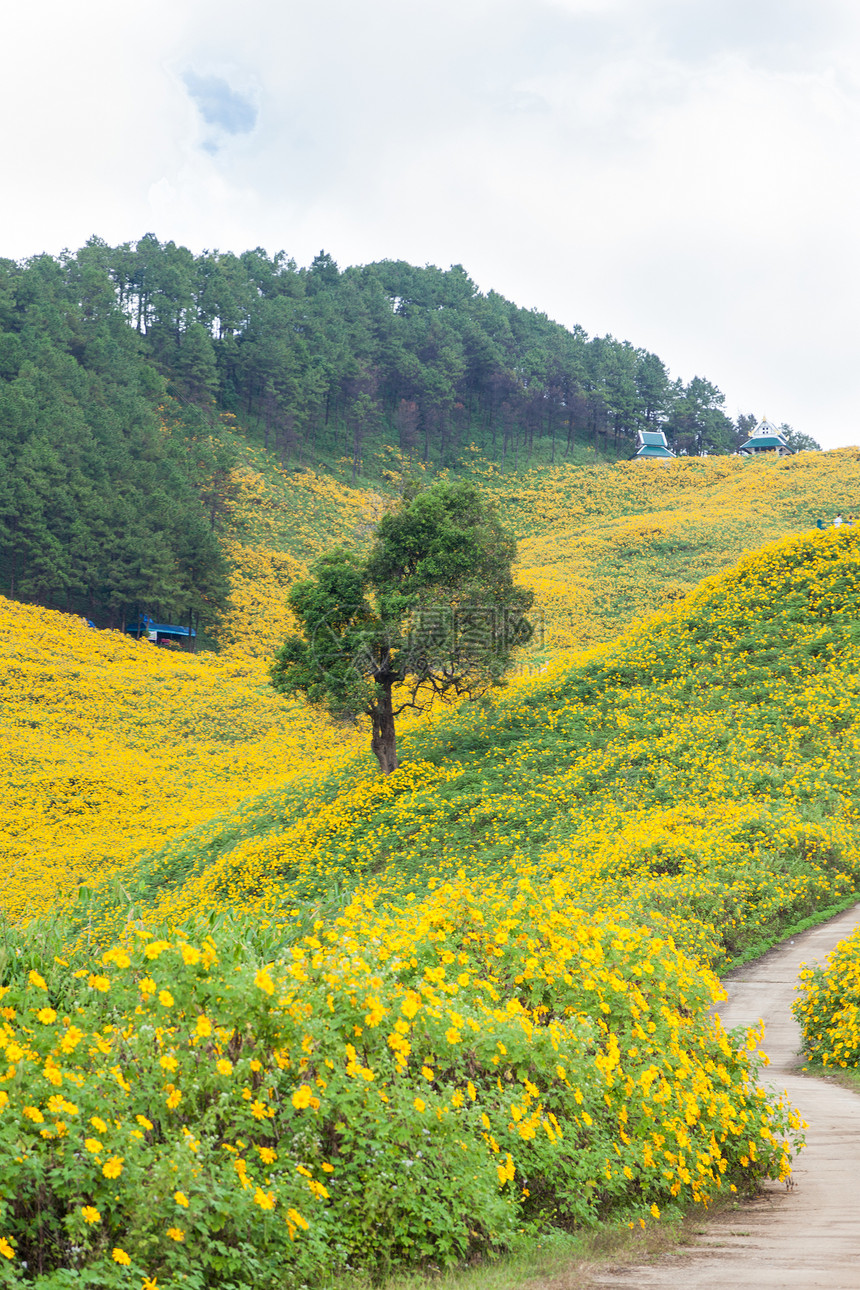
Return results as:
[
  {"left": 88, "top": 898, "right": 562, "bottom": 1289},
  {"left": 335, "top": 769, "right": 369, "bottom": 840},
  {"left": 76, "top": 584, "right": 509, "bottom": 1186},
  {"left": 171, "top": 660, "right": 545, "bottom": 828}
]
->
[{"left": 269, "top": 481, "right": 534, "bottom": 774}]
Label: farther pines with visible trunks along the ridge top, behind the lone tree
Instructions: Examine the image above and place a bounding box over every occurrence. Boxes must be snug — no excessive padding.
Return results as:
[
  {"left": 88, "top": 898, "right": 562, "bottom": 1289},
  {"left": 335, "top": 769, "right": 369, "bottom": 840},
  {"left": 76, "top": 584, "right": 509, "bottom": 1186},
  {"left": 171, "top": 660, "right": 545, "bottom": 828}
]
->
[{"left": 8, "top": 235, "right": 768, "bottom": 497}]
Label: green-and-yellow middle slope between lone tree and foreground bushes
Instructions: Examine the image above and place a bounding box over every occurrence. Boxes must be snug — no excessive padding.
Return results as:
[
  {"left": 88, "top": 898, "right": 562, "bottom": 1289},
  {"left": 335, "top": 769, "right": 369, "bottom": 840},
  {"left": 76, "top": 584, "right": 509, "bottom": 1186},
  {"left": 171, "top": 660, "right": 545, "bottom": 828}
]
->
[{"left": 70, "top": 529, "right": 860, "bottom": 966}]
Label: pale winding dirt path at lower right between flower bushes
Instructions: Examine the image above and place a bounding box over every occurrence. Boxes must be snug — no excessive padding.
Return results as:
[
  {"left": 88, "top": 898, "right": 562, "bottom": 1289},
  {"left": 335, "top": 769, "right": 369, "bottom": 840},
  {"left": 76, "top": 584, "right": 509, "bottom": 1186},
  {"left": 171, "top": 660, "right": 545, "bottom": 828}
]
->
[{"left": 592, "top": 906, "right": 860, "bottom": 1290}]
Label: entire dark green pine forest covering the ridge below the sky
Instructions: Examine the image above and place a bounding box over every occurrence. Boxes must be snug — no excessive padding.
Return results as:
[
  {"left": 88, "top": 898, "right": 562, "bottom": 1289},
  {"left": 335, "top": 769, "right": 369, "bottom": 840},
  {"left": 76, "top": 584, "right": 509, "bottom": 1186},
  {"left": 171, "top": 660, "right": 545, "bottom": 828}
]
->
[{"left": 0, "top": 235, "right": 820, "bottom": 626}]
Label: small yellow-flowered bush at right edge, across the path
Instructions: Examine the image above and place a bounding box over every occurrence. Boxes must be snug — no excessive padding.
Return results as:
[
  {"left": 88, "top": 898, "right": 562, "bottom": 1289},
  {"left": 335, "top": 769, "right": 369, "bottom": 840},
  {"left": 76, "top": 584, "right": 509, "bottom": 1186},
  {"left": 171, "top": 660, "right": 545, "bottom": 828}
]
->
[{"left": 794, "top": 929, "right": 860, "bottom": 1068}]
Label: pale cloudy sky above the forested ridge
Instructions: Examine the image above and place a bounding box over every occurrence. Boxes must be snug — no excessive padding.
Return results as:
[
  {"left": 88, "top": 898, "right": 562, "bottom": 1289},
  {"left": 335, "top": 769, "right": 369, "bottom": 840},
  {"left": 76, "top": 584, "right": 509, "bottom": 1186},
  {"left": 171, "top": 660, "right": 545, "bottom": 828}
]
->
[{"left": 0, "top": 0, "right": 860, "bottom": 448}]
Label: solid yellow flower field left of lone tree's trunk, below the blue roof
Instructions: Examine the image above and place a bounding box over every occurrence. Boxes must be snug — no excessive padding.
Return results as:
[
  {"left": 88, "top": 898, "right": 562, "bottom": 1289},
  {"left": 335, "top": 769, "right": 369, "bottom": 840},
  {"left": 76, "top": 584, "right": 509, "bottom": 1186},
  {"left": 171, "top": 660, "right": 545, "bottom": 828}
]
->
[{"left": 0, "top": 599, "right": 366, "bottom": 921}]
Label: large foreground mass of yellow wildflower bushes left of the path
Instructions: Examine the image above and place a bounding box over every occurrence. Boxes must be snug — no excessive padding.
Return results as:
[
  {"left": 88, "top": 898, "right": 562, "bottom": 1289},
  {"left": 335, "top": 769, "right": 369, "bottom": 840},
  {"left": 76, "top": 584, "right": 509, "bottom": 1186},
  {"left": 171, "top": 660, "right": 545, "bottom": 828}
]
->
[{"left": 0, "top": 903, "right": 799, "bottom": 1286}]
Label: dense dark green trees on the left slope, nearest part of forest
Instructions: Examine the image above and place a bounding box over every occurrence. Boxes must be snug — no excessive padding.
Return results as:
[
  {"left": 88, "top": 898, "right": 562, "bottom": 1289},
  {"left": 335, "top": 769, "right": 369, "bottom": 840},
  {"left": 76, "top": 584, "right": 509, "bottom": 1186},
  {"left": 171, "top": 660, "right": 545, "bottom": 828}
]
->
[{"left": 0, "top": 246, "right": 227, "bottom": 626}]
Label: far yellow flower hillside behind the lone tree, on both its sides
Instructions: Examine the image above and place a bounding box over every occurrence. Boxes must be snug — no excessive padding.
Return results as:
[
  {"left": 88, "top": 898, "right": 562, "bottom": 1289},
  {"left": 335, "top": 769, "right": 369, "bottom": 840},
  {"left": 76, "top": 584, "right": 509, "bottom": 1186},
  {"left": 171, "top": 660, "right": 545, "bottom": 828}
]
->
[{"left": 0, "top": 449, "right": 860, "bottom": 944}]
